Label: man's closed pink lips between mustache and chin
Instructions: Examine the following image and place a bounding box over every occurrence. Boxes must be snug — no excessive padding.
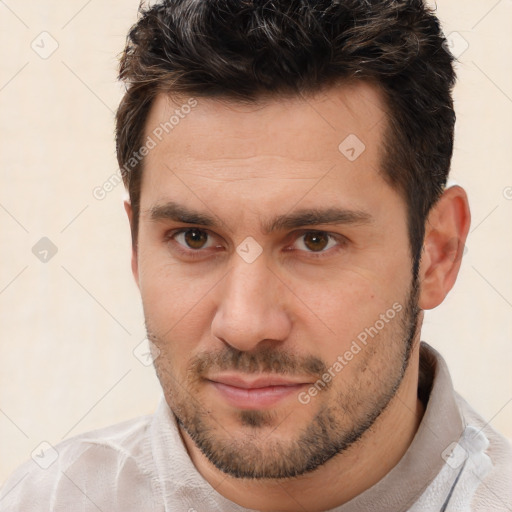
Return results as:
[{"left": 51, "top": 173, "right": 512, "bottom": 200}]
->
[{"left": 206, "top": 375, "right": 311, "bottom": 410}]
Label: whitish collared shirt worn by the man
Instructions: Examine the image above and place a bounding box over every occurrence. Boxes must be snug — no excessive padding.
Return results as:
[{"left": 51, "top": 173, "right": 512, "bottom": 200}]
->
[{"left": 0, "top": 343, "right": 512, "bottom": 512}]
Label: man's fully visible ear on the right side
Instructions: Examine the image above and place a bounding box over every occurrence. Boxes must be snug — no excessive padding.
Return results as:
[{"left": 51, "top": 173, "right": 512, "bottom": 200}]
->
[{"left": 419, "top": 185, "right": 471, "bottom": 309}]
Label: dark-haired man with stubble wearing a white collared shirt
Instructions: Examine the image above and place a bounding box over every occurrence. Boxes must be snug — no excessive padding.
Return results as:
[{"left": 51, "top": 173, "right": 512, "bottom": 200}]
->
[{"left": 0, "top": 0, "right": 512, "bottom": 512}]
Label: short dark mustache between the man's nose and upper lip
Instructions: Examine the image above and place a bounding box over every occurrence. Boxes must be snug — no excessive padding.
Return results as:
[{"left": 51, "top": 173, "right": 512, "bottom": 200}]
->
[{"left": 187, "top": 346, "right": 327, "bottom": 378}]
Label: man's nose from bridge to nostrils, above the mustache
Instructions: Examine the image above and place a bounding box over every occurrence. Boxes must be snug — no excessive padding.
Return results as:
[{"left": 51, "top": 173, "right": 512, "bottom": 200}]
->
[{"left": 211, "top": 255, "right": 292, "bottom": 351}]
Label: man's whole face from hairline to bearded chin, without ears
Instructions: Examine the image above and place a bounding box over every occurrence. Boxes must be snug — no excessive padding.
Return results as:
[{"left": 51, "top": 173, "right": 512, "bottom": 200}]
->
[{"left": 134, "top": 84, "right": 417, "bottom": 478}]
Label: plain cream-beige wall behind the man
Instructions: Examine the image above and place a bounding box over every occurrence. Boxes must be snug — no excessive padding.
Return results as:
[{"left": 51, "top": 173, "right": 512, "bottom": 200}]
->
[{"left": 0, "top": 0, "right": 512, "bottom": 482}]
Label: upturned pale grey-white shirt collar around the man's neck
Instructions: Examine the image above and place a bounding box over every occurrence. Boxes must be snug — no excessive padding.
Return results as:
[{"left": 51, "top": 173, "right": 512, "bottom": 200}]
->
[{"left": 150, "top": 342, "right": 464, "bottom": 512}]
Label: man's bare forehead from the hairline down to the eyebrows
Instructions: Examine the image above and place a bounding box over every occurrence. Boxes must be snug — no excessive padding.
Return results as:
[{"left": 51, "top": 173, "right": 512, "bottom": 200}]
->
[{"left": 141, "top": 82, "right": 394, "bottom": 218}]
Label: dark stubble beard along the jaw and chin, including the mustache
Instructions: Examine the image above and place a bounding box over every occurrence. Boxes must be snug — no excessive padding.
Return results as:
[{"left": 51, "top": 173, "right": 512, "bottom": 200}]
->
[{"left": 148, "top": 279, "right": 419, "bottom": 479}]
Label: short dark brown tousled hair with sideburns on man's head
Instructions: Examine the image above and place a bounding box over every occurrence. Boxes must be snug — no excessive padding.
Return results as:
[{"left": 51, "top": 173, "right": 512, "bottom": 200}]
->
[{"left": 116, "top": 0, "right": 455, "bottom": 275}]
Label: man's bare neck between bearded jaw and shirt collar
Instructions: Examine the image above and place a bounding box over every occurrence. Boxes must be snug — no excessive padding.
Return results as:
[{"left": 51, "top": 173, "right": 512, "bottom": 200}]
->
[{"left": 180, "top": 343, "right": 424, "bottom": 512}]
